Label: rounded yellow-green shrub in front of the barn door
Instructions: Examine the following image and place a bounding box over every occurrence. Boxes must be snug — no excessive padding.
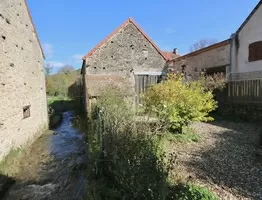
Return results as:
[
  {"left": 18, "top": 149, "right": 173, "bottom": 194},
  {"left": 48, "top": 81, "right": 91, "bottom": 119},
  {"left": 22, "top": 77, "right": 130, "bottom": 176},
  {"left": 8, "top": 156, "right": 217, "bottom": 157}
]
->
[{"left": 143, "top": 74, "right": 217, "bottom": 133}]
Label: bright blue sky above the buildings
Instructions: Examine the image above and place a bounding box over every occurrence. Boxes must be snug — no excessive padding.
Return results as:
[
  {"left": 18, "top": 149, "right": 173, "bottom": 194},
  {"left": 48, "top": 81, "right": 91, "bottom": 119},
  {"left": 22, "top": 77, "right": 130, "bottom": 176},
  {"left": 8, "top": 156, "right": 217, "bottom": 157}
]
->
[{"left": 27, "top": 0, "right": 259, "bottom": 71}]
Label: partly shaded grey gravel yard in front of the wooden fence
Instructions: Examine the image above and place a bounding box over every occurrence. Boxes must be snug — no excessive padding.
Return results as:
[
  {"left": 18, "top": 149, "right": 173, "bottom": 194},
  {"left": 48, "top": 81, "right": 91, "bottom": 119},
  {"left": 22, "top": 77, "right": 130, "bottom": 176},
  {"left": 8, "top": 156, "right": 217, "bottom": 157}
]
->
[{"left": 185, "top": 120, "right": 262, "bottom": 199}]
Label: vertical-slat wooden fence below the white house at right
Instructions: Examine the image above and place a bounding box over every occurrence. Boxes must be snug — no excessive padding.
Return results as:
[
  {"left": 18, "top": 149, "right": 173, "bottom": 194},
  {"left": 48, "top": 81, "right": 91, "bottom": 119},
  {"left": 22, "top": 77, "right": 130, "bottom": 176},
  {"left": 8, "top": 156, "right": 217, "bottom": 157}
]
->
[{"left": 216, "top": 79, "right": 262, "bottom": 104}]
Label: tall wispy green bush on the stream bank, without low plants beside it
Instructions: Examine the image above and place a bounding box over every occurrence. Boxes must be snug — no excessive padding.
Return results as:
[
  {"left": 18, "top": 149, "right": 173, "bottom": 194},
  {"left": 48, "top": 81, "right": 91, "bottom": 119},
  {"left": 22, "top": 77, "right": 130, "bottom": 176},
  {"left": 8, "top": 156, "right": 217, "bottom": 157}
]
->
[{"left": 87, "top": 88, "right": 175, "bottom": 200}]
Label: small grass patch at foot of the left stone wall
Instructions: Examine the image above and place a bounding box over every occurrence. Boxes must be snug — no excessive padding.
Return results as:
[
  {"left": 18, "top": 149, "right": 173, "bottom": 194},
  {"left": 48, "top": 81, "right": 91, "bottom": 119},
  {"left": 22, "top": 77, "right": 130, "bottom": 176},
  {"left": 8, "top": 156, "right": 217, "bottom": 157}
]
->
[{"left": 0, "top": 148, "right": 23, "bottom": 175}]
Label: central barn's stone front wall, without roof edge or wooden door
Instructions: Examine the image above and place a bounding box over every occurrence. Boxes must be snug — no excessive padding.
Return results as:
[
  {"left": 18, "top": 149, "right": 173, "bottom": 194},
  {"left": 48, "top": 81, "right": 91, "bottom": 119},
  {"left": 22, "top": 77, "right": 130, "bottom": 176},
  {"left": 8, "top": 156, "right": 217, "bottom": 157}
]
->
[{"left": 82, "top": 22, "right": 166, "bottom": 112}]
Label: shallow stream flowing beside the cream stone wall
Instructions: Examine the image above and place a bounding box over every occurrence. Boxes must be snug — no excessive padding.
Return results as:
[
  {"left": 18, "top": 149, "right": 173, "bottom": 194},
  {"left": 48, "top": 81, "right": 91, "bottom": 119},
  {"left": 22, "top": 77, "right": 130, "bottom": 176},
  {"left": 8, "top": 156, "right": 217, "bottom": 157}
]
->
[{"left": 4, "top": 112, "right": 87, "bottom": 200}]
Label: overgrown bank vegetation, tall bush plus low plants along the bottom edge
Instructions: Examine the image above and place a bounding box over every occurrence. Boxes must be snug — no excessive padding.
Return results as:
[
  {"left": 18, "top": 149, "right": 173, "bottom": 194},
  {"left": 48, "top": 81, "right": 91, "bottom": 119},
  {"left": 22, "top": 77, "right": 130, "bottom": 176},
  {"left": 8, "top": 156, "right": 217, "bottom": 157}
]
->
[{"left": 86, "top": 86, "right": 218, "bottom": 200}]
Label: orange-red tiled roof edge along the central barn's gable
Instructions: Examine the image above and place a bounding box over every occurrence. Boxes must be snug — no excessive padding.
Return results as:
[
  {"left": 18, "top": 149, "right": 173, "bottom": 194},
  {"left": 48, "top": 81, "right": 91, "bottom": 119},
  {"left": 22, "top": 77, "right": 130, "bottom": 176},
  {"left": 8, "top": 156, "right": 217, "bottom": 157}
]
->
[{"left": 82, "top": 18, "right": 166, "bottom": 60}]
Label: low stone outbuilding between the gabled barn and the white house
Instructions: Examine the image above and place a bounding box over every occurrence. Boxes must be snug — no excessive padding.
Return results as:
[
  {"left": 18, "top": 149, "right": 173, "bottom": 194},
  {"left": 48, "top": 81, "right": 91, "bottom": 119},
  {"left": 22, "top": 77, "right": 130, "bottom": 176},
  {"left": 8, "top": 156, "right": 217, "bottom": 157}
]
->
[{"left": 170, "top": 40, "right": 230, "bottom": 77}]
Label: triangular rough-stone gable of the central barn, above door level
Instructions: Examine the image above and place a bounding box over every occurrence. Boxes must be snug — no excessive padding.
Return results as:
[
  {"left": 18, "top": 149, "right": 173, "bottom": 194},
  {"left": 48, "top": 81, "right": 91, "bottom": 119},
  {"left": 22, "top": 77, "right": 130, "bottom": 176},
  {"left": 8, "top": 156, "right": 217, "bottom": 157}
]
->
[{"left": 86, "top": 23, "right": 165, "bottom": 74}]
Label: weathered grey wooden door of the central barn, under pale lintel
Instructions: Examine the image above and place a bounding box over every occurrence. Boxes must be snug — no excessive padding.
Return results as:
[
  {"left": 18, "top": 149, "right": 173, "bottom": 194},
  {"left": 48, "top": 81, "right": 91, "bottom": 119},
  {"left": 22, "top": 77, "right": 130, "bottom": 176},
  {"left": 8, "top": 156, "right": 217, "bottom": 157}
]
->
[{"left": 135, "top": 72, "right": 163, "bottom": 105}]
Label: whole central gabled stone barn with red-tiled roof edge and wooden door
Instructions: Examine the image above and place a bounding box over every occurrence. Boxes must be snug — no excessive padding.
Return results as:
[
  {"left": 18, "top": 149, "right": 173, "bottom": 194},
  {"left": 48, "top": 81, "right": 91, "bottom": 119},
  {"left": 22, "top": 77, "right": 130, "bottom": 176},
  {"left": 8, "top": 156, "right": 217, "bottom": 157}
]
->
[{"left": 82, "top": 18, "right": 180, "bottom": 110}]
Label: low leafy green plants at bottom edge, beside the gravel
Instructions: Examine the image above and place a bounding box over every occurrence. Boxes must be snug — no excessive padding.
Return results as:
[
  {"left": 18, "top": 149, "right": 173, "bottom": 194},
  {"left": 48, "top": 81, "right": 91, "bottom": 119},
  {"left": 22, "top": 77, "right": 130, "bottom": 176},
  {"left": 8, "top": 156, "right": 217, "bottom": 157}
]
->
[{"left": 166, "top": 184, "right": 219, "bottom": 200}]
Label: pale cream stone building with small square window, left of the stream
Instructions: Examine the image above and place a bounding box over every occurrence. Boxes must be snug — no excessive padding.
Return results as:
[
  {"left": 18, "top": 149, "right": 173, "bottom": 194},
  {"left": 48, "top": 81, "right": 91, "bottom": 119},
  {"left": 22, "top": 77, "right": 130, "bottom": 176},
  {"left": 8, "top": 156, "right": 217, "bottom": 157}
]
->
[{"left": 0, "top": 0, "right": 48, "bottom": 159}]
